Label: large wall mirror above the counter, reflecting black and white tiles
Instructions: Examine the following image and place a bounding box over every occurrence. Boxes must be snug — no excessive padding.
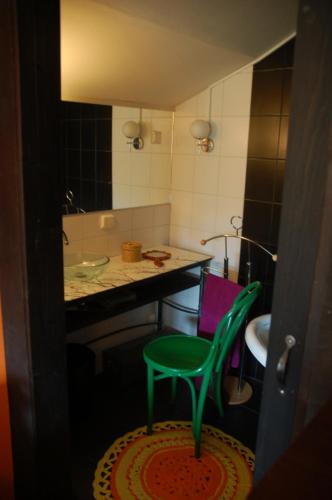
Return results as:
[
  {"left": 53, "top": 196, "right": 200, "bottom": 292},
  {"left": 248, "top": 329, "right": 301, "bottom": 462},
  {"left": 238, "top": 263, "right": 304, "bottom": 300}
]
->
[{"left": 61, "top": 101, "right": 173, "bottom": 214}]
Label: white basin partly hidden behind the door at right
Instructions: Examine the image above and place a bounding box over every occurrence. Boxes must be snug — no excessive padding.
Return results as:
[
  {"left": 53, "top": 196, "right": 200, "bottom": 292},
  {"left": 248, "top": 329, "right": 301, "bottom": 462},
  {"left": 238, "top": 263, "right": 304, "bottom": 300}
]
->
[{"left": 245, "top": 314, "right": 271, "bottom": 366}]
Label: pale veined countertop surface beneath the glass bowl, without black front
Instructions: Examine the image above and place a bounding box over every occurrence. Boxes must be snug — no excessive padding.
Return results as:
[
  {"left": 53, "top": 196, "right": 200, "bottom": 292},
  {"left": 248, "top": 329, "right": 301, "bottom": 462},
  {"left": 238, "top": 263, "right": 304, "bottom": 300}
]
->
[{"left": 65, "top": 245, "right": 213, "bottom": 301}]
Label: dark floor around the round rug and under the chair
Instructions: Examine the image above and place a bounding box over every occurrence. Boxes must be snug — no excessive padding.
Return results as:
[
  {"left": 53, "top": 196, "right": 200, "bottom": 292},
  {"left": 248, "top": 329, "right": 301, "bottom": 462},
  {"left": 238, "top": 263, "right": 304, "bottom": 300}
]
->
[{"left": 72, "top": 366, "right": 260, "bottom": 500}]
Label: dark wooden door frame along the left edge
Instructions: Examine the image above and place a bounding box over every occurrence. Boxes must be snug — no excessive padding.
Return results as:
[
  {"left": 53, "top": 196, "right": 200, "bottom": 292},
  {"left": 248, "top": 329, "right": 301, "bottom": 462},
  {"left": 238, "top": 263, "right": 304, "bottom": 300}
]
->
[{"left": 0, "top": 0, "right": 70, "bottom": 499}]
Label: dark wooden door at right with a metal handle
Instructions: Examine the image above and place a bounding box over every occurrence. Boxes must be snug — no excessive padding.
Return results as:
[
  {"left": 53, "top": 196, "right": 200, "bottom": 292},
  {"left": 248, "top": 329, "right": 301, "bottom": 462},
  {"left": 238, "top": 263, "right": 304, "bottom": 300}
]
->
[{"left": 255, "top": 0, "right": 332, "bottom": 480}]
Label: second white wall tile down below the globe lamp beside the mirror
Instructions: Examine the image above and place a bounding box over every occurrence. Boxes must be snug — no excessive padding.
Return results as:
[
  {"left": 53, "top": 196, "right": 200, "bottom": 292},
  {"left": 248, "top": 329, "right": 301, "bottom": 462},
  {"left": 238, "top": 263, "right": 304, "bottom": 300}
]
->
[{"left": 191, "top": 194, "right": 217, "bottom": 232}]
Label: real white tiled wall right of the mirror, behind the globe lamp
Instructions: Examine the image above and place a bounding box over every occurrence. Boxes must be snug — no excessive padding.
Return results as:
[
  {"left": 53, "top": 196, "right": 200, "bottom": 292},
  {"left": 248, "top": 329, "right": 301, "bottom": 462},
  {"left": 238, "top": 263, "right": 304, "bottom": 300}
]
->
[{"left": 167, "top": 66, "right": 253, "bottom": 333}]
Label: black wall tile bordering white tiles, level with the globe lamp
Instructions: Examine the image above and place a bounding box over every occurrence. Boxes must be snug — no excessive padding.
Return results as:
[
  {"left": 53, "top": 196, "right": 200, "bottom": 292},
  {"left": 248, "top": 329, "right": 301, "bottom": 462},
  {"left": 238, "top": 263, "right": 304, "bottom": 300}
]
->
[{"left": 248, "top": 116, "right": 280, "bottom": 158}]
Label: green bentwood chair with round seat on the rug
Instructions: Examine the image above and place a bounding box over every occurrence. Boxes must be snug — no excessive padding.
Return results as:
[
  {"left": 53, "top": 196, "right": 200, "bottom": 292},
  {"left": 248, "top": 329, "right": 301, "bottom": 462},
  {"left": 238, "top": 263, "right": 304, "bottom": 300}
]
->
[{"left": 143, "top": 281, "right": 262, "bottom": 458}]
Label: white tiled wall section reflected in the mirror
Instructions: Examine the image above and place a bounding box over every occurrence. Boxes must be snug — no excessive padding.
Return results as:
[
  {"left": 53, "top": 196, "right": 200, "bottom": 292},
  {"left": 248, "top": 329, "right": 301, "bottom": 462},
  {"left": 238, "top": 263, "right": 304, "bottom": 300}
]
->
[{"left": 112, "top": 106, "right": 173, "bottom": 208}]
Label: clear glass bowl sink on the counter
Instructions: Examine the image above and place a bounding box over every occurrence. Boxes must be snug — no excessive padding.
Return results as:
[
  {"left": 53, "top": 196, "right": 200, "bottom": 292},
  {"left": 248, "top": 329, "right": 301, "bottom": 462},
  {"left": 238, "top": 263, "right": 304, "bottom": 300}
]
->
[{"left": 63, "top": 252, "right": 110, "bottom": 281}]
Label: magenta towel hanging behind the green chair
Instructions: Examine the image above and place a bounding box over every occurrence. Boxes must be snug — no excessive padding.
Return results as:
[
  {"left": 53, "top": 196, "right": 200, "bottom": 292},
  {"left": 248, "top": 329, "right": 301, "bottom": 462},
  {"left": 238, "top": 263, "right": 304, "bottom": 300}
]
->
[{"left": 199, "top": 274, "right": 243, "bottom": 368}]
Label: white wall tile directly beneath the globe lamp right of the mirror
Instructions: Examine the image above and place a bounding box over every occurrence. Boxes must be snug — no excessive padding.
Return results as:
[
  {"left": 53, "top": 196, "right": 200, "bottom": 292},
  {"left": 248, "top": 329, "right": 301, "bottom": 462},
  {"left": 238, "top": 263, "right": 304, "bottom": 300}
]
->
[{"left": 194, "top": 153, "right": 219, "bottom": 194}]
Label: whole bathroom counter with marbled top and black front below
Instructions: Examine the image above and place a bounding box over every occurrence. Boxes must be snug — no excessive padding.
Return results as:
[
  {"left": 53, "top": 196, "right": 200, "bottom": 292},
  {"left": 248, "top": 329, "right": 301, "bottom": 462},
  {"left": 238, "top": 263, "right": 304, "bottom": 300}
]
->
[{"left": 64, "top": 245, "right": 213, "bottom": 332}]
